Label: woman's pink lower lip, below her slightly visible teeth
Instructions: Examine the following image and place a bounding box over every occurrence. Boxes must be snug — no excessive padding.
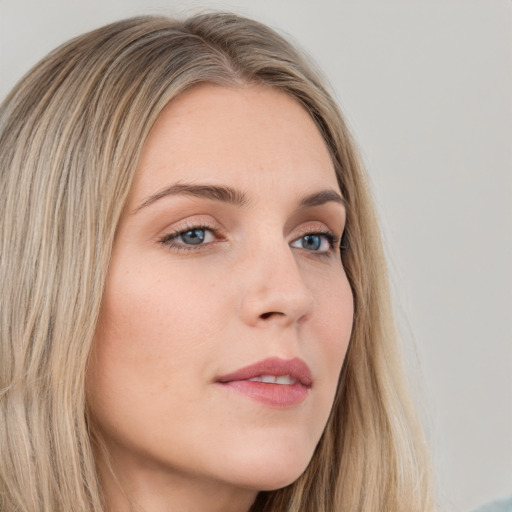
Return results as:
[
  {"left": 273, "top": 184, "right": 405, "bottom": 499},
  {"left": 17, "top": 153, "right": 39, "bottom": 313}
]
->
[{"left": 221, "top": 380, "right": 309, "bottom": 409}]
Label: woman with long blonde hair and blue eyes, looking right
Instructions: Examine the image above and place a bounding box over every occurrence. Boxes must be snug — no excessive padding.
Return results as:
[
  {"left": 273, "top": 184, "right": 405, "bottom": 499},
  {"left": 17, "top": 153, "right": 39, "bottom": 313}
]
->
[{"left": 0, "top": 14, "right": 433, "bottom": 512}]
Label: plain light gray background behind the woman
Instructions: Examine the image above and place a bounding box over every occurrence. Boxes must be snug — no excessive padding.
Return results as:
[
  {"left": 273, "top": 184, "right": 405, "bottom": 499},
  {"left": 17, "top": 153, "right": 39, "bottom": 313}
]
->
[{"left": 0, "top": 0, "right": 512, "bottom": 512}]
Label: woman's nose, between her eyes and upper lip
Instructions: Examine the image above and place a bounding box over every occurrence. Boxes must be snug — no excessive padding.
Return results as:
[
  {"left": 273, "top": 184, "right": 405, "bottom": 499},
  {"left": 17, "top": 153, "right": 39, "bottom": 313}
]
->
[{"left": 241, "top": 238, "right": 314, "bottom": 327}]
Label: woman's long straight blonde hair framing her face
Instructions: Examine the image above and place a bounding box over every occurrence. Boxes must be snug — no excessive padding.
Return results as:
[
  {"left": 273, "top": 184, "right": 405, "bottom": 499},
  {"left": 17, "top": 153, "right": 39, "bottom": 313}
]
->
[{"left": 0, "top": 13, "right": 433, "bottom": 512}]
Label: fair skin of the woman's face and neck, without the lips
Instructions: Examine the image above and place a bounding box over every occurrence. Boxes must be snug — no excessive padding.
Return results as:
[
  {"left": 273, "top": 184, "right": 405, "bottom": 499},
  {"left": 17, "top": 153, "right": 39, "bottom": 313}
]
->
[{"left": 87, "top": 84, "right": 353, "bottom": 512}]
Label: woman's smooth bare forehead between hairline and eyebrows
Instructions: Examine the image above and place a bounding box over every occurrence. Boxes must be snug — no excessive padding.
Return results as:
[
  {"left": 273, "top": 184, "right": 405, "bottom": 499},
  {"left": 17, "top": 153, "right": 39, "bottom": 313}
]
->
[{"left": 128, "top": 84, "right": 338, "bottom": 204}]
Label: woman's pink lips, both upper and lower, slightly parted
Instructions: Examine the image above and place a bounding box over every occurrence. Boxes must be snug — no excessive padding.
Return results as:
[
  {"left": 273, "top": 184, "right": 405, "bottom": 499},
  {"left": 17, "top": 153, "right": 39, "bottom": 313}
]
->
[{"left": 216, "top": 357, "right": 313, "bottom": 409}]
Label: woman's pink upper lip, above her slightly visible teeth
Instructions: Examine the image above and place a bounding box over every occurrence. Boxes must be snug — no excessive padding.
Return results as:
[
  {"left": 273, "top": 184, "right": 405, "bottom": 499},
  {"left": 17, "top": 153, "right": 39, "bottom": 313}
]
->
[{"left": 217, "top": 357, "right": 313, "bottom": 387}]
